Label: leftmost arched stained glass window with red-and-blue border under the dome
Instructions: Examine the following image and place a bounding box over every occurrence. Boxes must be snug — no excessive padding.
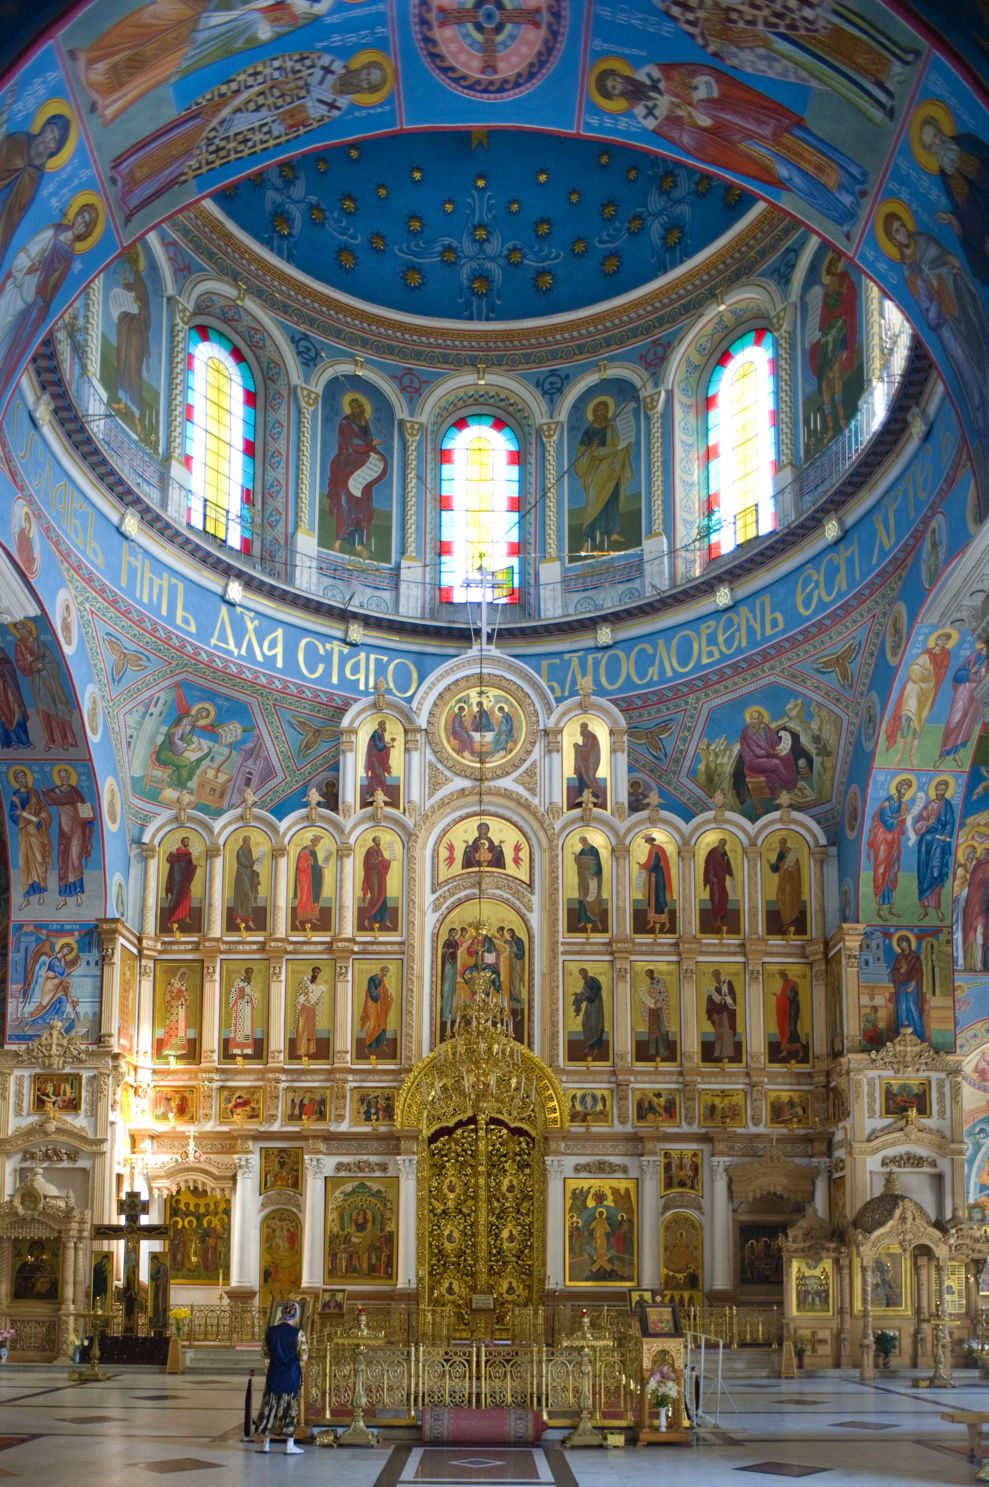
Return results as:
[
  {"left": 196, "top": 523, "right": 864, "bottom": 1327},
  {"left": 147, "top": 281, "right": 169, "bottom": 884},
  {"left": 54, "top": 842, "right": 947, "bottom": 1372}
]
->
[{"left": 186, "top": 326, "right": 257, "bottom": 553}]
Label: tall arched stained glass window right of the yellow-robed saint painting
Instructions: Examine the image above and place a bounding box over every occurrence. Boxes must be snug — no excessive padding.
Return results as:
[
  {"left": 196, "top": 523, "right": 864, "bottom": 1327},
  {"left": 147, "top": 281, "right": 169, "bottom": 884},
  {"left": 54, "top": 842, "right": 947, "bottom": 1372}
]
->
[{"left": 703, "top": 329, "right": 778, "bottom": 558}]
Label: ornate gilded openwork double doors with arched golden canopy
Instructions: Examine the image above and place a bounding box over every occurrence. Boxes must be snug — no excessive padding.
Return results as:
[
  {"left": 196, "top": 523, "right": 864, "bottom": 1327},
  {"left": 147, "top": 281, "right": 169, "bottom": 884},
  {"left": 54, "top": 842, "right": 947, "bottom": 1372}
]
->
[{"left": 396, "top": 993, "right": 568, "bottom": 1337}]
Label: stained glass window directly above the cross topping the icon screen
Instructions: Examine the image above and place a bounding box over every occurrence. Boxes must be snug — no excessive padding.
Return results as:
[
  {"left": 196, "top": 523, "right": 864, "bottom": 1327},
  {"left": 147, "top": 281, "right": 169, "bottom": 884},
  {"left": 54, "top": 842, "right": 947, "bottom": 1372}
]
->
[{"left": 440, "top": 413, "right": 519, "bottom": 604}]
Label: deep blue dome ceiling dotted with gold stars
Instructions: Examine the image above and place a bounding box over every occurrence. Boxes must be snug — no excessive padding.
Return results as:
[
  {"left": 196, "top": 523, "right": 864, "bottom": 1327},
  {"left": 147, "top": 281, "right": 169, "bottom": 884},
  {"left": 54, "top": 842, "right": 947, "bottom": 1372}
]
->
[{"left": 214, "top": 131, "right": 754, "bottom": 321}]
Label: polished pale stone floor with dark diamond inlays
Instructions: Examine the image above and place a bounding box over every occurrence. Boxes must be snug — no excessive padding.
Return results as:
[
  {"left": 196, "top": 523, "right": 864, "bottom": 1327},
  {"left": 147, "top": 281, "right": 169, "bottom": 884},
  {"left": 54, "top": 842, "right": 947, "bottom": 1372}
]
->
[{"left": 0, "top": 1364, "right": 989, "bottom": 1487}]
